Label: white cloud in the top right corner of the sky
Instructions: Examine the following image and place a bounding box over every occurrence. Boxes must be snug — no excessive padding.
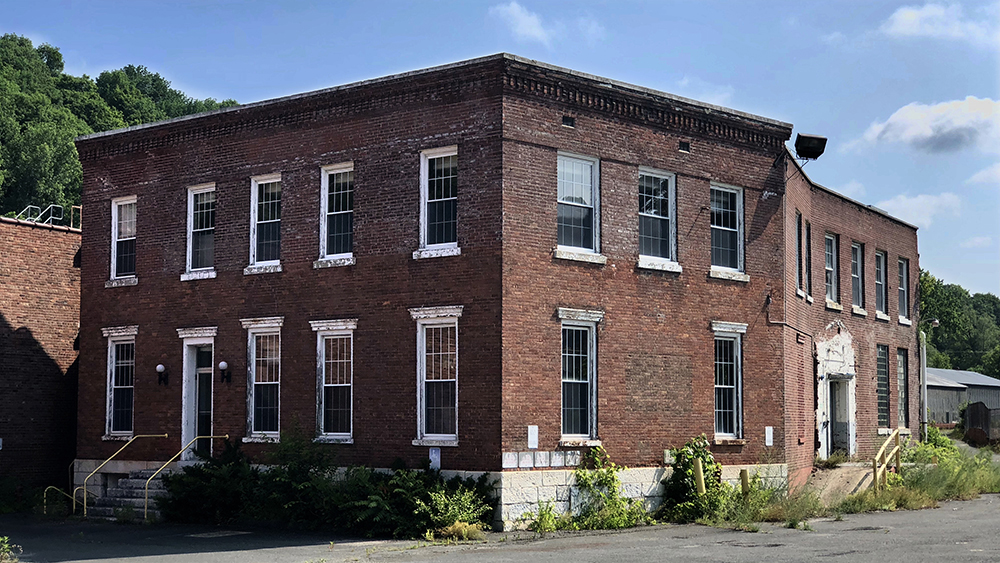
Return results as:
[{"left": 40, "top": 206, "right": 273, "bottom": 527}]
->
[{"left": 879, "top": 3, "right": 1000, "bottom": 46}]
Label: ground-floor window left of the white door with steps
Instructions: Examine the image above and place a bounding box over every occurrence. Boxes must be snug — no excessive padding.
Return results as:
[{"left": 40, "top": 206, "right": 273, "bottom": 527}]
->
[{"left": 102, "top": 326, "right": 139, "bottom": 437}]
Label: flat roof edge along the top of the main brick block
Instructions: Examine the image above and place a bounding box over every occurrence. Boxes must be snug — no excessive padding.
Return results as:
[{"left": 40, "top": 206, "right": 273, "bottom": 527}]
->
[{"left": 74, "top": 53, "right": 792, "bottom": 142}]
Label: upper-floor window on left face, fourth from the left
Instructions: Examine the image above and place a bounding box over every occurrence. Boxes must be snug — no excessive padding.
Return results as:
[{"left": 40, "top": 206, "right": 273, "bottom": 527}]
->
[{"left": 319, "top": 162, "right": 354, "bottom": 258}]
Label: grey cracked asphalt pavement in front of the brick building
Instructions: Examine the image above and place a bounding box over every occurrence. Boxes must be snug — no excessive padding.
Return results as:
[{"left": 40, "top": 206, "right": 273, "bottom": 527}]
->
[{"left": 0, "top": 495, "right": 1000, "bottom": 563}]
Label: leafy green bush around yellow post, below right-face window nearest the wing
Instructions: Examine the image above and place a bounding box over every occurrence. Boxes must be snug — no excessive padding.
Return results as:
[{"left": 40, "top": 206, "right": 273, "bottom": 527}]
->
[{"left": 657, "top": 434, "right": 731, "bottom": 522}]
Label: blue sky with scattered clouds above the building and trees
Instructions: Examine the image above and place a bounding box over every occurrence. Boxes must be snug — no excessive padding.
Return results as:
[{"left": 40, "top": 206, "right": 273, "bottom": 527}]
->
[{"left": 7, "top": 0, "right": 1000, "bottom": 294}]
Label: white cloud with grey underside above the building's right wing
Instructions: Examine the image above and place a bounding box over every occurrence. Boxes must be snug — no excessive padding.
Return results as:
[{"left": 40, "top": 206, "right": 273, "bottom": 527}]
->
[{"left": 844, "top": 96, "right": 1000, "bottom": 153}]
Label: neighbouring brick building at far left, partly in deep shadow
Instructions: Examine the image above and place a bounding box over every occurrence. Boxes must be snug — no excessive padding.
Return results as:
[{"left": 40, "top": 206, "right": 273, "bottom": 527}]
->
[{"left": 0, "top": 217, "right": 80, "bottom": 487}]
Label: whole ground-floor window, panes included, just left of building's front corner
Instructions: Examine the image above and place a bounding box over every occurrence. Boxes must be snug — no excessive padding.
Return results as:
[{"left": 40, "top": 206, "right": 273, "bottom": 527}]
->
[{"left": 410, "top": 305, "right": 462, "bottom": 445}]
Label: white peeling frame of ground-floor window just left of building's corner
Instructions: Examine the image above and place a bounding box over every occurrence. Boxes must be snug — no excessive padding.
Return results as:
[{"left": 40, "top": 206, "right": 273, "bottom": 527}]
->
[{"left": 410, "top": 305, "right": 464, "bottom": 447}]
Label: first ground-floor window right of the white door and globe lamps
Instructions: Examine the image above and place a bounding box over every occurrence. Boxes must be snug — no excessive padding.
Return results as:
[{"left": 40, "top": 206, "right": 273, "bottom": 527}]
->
[{"left": 241, "top": 317, "right": 284, "bottom": 441}]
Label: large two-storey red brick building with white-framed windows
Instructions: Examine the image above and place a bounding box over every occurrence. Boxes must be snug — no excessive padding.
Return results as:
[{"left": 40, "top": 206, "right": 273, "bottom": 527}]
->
[{"left": 78, "top": 54, "right": 918, "bottom": 515}]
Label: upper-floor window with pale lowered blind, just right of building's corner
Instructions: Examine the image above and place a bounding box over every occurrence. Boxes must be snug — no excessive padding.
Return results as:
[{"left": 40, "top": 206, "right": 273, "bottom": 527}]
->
[{"left": 557, "top": 154, "right": 600, "bottom": 252}]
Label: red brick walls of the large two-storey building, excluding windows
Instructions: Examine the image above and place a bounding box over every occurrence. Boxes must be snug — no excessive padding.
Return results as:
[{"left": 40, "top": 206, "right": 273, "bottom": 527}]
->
[{"left": 78, "top": 55, "right": 918, "bottom": 492}]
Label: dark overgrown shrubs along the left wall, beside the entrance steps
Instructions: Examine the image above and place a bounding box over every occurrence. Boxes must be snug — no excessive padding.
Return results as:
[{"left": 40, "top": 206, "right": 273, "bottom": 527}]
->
[{"left": 159, "top": 432, "right": 496, "bottom": 538}]
